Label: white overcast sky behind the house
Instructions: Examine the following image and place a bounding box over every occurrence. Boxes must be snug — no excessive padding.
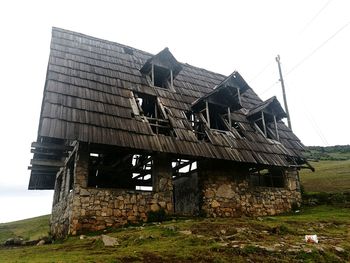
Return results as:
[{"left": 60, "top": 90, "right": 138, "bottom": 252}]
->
[{"left": 0, "top": 0, "right": 350, "bottom": 222}]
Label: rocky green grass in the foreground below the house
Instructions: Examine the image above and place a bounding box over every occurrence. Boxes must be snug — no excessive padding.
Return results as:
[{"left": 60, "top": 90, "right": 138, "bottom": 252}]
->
[{"left": 0, "top": 206, "right": 350, "bottom": 262}]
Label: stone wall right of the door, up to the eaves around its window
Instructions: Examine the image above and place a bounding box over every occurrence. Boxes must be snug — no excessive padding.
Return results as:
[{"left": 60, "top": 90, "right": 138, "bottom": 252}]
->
[{"left": 200, "top": 163, "right": 301, "bottom": 217}]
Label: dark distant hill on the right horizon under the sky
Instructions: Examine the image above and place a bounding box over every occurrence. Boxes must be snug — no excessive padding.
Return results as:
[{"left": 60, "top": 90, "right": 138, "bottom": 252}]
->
[{"left": 305, "top": 145, "right": 350, "bottom": 161}]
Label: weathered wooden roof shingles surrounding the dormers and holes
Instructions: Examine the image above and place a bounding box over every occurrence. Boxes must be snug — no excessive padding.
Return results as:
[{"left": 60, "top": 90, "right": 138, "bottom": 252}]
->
[{"left": 31, "top": 28, "right": 303, "bottom": 186}]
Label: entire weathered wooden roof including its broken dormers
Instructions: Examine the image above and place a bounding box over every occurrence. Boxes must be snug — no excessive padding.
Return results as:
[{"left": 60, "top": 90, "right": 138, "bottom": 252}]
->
[{"left": 32, "top": 28, "right": 305, "bottom": 188}]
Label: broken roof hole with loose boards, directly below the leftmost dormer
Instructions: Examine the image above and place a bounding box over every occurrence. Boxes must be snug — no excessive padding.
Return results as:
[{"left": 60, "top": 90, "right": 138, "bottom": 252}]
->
[{"left": 133, "top": 93, "right": 176, "bottom": 137}]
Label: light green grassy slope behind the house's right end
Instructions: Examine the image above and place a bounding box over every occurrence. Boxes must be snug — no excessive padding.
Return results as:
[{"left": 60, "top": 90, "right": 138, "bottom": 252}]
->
[{"left": 300, "top": 160, "right": 350, "bottom": 192}]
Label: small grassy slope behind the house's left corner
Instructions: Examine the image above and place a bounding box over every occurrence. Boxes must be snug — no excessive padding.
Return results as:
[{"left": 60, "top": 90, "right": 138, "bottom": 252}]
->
[{"left": 0, "top": 215, "right": 50, "bottom": 244}]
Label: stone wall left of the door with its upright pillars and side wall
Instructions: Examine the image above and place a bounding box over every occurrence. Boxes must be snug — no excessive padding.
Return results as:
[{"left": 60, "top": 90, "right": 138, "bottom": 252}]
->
[{"left": 51, "top": 144, "right": 174, "bottom": 237}]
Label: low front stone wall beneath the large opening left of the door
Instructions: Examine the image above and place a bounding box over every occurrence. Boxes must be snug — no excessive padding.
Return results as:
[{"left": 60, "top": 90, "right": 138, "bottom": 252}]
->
[{"left": 70, "top": 188, "right": 173, "bottom": 235}]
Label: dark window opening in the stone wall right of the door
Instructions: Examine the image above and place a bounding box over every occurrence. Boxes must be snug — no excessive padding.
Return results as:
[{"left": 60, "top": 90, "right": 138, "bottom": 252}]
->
[{"left": 250, "top": 168, "right": 285, "bottom": 188}]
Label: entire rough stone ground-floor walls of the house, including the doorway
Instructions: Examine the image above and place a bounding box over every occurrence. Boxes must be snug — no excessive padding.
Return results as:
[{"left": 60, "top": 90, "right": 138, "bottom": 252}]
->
[{"left": 50, "top": 144, "right": 301, "bottom": 238}]
